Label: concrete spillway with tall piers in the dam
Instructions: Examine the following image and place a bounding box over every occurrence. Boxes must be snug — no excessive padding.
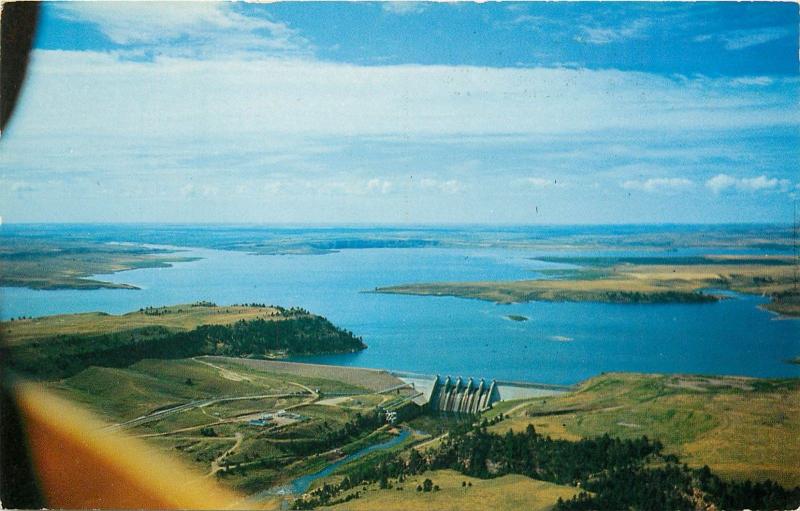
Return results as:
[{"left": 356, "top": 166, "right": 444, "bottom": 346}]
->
[{"left": 429, "top": 376, "right": 500, "bottom": 414}]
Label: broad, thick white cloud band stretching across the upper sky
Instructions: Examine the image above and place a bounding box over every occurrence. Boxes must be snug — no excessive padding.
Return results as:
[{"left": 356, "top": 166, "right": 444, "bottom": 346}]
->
[{"left": 15, "top": 51, "right": 800, "bottom": 145}]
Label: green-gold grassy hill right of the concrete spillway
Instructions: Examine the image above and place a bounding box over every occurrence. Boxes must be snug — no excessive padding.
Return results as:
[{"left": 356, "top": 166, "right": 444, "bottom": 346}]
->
[{"left": 486, "top": 373, "right": 800, "bottom": 486}]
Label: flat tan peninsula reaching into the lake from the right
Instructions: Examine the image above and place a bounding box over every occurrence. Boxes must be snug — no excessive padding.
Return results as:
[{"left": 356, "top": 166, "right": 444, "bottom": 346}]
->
[{"left": 374, "top": 255, "right": 800, "bottom": 316}]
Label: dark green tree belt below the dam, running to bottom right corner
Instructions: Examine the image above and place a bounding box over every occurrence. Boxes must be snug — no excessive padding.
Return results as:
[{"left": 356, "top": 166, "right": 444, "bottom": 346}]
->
[{"left": 292, "top": 421, "right": 800, "bottom": 511}]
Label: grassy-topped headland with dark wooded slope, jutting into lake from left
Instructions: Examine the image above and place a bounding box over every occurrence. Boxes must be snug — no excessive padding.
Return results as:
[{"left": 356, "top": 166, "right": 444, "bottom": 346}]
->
[{"left": 0, "top": 303, "right": 366, "bottom": 379}]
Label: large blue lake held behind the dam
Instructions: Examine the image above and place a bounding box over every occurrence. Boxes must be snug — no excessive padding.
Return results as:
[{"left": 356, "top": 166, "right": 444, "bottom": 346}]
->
[{"left": 2, "top": 244, "right": 800, "bottom": 384}]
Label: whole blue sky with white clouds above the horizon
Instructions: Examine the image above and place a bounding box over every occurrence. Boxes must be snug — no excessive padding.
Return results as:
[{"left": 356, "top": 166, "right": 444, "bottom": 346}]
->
[{"left": 0, "top": 2, "right": 800, "bottom": 224}]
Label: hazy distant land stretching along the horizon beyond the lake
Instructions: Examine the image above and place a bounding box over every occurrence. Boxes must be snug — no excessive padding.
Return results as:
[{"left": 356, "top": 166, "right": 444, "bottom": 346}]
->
[{"left": 0, "top": 224, "right": 797, "bottom": 292}]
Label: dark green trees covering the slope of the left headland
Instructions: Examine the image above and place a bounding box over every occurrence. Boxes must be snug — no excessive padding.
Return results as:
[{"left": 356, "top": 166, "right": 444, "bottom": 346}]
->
[{"left": 9, "top": 315, "right": 366, "bottom": 378}]
